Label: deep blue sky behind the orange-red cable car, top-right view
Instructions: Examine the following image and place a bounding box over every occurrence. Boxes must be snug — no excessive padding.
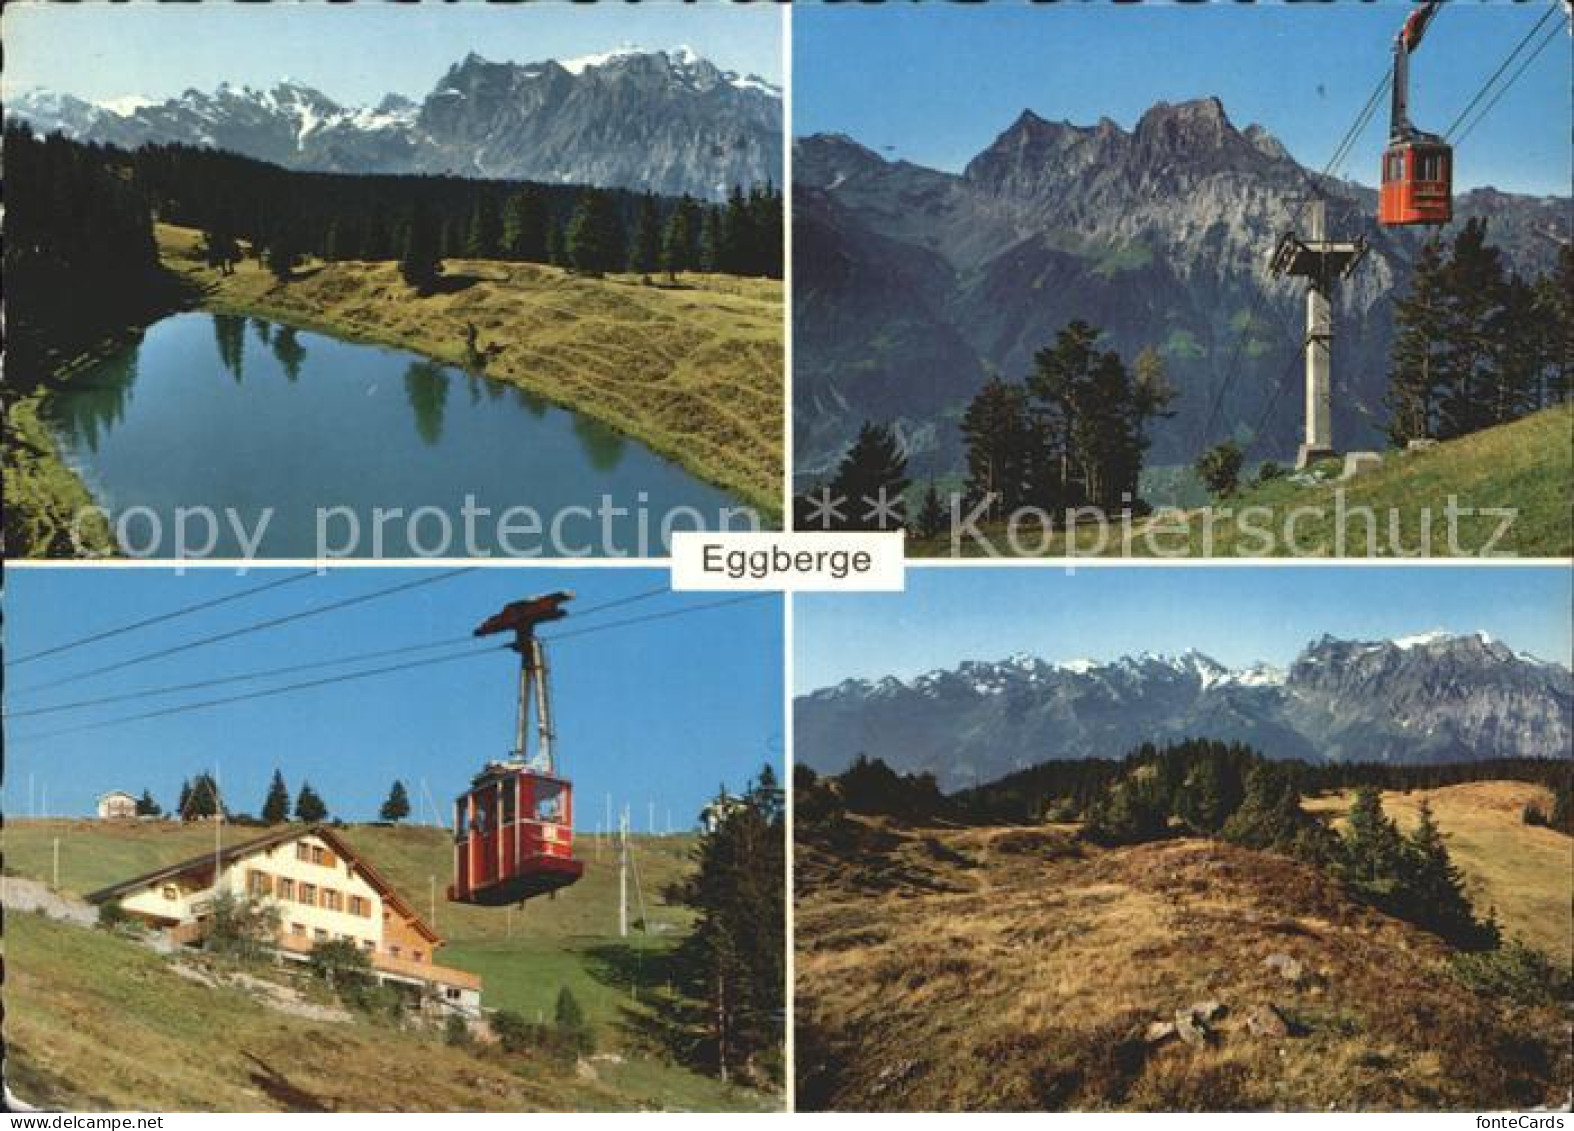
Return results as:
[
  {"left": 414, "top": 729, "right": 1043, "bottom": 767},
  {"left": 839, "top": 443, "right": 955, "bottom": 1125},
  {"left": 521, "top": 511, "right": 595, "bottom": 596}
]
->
[{"left": 793, "top": 0, "right": 1571, "bottom": 193}]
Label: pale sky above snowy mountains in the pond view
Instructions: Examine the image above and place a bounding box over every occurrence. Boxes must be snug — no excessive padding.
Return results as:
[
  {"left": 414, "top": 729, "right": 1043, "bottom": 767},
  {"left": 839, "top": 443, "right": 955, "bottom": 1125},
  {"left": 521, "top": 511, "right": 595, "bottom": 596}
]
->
[{"left": 3, "top": 0, "right": 782, "bottom": 104}]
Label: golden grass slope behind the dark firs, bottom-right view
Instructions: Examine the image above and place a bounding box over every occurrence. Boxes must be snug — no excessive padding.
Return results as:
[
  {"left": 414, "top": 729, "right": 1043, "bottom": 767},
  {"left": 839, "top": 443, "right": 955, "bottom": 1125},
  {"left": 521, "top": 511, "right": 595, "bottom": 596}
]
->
[{"left": 1306, "top": 782, "right": 1574, "bottom": 966}]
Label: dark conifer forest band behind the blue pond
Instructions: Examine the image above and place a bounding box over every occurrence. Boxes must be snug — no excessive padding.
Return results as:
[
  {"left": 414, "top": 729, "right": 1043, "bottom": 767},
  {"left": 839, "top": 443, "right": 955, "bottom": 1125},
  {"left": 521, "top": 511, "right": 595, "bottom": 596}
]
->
[{"left": 5, "top": 124, "right": 782, "bottom": 387}]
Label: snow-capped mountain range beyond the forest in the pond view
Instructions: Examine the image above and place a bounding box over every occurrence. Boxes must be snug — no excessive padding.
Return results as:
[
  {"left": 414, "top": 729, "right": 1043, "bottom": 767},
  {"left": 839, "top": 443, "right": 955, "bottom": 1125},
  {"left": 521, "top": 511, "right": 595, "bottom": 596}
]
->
[{"left": 5, "top": 47, "right": 782, "bottom": 198}]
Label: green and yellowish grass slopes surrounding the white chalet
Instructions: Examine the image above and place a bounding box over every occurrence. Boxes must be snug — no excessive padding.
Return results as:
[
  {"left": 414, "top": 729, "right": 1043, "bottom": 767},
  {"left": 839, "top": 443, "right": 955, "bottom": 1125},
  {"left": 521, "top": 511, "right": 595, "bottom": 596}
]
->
[{"left": 0, "top": 820, "right": 781, "bottom": 1111}]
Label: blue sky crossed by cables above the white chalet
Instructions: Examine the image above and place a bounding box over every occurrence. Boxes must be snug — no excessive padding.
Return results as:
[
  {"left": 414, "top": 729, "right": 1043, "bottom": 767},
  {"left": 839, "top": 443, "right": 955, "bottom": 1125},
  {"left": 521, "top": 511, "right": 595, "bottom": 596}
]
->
[{"left": 5, "top": 568, "right": 782, "bottom": 832}]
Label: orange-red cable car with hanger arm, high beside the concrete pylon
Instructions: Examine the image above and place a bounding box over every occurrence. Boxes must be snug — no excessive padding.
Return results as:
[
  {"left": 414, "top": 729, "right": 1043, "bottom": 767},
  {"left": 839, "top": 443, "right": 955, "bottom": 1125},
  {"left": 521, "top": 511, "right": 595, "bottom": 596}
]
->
[{"left": 1377, "top": 0, "right": 1454, "bottom": 225}]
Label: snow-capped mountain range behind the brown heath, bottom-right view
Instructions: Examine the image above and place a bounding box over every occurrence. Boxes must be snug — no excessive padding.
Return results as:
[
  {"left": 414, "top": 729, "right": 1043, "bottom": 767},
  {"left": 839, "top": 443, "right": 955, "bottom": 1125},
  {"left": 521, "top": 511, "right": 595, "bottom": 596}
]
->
[{"left": 795, "top": 632, "right": 1574, "bottom": 791}]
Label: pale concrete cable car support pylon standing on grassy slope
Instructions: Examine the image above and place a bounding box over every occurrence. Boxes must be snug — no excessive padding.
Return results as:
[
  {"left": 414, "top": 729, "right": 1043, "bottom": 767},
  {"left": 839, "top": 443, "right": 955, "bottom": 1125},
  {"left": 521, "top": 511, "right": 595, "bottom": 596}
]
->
[{"left": 1269, "top": 197, "right": 1366, "bottom": 467}]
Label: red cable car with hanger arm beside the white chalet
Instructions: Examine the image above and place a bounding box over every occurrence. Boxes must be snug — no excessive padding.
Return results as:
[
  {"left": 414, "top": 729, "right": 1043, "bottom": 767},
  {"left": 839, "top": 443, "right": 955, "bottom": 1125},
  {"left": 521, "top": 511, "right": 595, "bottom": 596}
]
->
[{"left": 449, "top": 593, "right": 586, "bottom": 908}]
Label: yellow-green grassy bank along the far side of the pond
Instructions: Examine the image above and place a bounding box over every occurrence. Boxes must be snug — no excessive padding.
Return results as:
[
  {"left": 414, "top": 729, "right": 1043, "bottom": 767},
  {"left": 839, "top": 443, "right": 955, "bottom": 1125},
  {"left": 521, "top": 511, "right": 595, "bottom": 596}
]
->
[{"left": 157, "top": 225, "right": 784, "bottom": 518}]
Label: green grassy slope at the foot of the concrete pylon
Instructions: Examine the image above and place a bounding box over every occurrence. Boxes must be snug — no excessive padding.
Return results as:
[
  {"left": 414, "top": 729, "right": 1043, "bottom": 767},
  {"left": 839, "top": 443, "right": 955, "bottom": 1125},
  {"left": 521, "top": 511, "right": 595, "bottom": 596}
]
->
[{"left": 908, "top": 404, "right": 1574, "bottom": 557}]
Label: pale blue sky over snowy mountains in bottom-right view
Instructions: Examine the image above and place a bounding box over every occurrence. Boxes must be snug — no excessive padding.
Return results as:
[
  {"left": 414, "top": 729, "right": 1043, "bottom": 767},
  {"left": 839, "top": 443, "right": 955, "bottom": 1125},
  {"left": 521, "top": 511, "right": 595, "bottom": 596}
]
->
[{"left": 793, "top": 566, "right": 1574, "bottom": 694}]
